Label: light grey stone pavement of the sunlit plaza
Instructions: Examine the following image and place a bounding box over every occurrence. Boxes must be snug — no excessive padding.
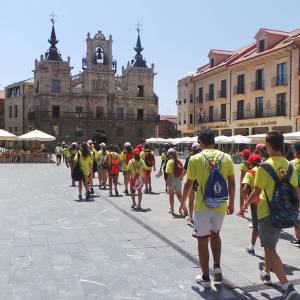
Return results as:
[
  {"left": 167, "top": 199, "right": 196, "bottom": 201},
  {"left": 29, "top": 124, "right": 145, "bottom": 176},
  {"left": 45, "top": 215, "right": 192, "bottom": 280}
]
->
[{"left": 0, "top": 164, "right": 300, "bottom": 300}]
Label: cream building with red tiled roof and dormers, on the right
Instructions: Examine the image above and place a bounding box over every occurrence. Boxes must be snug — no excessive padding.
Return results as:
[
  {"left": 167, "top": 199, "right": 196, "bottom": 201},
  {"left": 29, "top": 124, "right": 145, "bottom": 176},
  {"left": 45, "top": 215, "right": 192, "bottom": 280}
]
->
[{"left": 177, "top": 28, "right": 300, "bottom": 136}]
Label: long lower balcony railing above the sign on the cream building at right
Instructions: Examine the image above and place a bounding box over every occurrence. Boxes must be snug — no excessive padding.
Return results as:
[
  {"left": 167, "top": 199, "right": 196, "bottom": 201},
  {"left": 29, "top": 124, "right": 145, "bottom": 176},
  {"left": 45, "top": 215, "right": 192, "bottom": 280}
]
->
[{"left": 233, "top": 107, "right": 287, "bottom": 120}]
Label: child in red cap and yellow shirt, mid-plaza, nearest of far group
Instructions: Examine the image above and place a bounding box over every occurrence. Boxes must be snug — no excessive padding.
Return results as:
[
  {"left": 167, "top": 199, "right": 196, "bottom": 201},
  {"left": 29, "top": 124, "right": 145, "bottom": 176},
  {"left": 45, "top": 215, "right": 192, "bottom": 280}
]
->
[{"left": 128, "top": 149, "right": 146, "bottom": 209}]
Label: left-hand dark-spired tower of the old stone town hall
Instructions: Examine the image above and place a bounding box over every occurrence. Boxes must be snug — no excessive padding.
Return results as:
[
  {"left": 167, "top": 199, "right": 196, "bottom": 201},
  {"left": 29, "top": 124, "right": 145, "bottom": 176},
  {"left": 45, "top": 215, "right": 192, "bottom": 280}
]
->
[{"left": 34, "top": 18, "right": 71, "bottom": 95}]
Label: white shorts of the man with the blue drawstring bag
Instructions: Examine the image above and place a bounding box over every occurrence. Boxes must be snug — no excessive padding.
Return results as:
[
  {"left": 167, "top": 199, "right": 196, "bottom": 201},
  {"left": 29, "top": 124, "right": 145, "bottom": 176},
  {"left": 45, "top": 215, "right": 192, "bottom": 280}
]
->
[{"left": 193, "top": 210, "right": 225, "bottom": 238}]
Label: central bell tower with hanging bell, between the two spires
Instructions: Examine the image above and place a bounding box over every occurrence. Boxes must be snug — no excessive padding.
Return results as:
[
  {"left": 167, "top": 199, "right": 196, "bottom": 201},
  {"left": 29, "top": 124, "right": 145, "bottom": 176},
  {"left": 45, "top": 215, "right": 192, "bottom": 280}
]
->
[{"left": 82, "top": 31, "right": 117, "bottom": 94}]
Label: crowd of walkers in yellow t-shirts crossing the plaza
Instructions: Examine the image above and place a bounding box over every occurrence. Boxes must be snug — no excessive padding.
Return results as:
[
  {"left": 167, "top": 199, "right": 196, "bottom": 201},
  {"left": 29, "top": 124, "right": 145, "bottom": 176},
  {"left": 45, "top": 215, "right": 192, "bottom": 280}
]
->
[{"left": 56, "top": 129, "right": 300, "bottom": 300}]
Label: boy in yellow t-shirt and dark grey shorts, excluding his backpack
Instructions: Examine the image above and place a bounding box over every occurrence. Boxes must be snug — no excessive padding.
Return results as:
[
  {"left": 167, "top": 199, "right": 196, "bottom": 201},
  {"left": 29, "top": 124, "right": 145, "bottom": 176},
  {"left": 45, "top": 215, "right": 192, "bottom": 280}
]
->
[{"left": 247, "top": 131, "right": 300, "bottom": 299}]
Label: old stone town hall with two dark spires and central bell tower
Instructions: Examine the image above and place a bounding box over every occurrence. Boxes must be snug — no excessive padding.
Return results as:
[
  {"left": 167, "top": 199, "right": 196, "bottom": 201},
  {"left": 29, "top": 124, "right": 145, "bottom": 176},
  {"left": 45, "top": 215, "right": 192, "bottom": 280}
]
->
[{"left": 5, "top": 24, "right": 159, "bottom": 143}]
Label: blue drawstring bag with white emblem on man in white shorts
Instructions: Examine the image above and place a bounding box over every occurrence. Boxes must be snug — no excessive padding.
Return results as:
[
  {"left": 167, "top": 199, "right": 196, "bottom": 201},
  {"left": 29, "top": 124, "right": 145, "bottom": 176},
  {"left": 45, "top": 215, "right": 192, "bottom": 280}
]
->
[{"left": 202, "top": 154, "right": 228, "bottom": 208}]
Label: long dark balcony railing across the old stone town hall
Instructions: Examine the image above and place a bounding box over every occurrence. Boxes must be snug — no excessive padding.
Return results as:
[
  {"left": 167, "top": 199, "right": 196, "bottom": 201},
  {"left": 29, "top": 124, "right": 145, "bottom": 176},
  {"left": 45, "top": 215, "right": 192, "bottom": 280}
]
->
[{"left": 28, "top": 111, "right": 159, "bottom": 121}]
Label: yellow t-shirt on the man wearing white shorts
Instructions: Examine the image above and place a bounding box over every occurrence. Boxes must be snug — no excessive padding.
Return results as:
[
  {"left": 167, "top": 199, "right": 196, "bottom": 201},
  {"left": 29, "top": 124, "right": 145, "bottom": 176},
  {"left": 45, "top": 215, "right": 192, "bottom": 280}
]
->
[{"left": 187, "top": 149, "right": 234, "bottom": 213}]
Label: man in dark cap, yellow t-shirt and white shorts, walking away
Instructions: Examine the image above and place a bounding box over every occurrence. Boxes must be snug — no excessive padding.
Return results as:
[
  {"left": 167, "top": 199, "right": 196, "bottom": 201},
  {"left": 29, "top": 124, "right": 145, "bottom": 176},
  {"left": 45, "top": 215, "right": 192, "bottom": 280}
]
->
[{"left": 180, "top": 129, "right": 235, "bottom": 288}]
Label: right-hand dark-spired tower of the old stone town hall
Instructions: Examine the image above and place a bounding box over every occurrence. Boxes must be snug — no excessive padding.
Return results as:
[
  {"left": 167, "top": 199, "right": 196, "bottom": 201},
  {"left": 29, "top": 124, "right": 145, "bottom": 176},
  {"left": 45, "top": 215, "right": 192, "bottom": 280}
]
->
[{"left": 122, "top": 27, "right": 155, "bottom": 98}]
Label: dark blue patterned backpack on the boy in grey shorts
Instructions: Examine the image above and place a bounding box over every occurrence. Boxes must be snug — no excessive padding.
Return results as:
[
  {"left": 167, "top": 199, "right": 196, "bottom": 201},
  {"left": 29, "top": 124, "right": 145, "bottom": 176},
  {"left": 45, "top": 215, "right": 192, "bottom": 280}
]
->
[{"left": 260, "top": 162, "right": 299, "bottom": 229}]
